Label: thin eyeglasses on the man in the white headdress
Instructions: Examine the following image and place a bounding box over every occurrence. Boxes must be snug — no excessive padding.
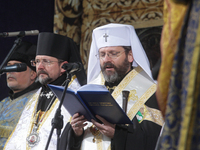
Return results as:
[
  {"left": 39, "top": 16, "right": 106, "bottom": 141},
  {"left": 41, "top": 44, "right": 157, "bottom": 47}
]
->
[{"left": 95, "top": 50, "right": 125, "bottom": 59}]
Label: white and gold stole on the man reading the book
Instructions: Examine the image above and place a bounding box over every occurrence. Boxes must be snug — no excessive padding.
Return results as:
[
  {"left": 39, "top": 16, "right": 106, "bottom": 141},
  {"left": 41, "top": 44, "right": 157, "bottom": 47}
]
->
[{"left": 83, "top": 66, "right": 159, "bottom": 150}]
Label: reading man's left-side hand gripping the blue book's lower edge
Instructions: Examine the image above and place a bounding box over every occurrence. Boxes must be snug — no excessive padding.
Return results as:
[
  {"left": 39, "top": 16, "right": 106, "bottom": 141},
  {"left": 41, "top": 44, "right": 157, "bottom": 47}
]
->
[{"left": 71, "top": 113, "right": 87, "bottom": 136}]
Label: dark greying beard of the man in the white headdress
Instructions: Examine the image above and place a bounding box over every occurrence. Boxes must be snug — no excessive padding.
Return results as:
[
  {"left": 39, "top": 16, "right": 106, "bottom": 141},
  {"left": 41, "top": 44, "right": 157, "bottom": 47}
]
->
[{"left": 101, "top": 57, "right": 130, "bottom": 83}]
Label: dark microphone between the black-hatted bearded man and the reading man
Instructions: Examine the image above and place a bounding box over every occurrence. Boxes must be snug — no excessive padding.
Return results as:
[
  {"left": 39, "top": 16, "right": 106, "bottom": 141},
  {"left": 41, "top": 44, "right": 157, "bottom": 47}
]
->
[{"left": 62, "top": 62, "right": 82, "bottom": 73}]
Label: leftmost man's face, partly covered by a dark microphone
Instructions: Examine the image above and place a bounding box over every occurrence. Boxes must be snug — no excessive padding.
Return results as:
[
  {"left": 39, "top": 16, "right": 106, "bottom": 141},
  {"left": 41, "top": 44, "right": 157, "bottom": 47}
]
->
[{"left": 6, "top": 60, "right": 37, "bottom": 93}]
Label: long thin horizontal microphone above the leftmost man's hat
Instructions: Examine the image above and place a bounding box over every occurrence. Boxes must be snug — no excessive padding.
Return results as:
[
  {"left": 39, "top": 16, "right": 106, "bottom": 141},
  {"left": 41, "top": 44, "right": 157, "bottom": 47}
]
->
[{"left": 0, "top": 30, "right": 39, "bottom": 37}]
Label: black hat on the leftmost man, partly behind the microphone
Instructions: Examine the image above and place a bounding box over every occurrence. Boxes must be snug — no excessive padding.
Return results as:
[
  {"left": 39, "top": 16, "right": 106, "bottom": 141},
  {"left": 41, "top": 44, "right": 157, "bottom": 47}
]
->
[{"left": 8, "top": 41, "right": 37, "bottom": 71}]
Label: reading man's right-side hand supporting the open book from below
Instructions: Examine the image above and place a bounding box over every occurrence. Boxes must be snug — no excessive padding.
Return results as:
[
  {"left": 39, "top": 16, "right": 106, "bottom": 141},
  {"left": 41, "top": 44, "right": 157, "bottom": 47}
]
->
[{"left": 92, "top": 115, "right": 115, "bottom": 139}]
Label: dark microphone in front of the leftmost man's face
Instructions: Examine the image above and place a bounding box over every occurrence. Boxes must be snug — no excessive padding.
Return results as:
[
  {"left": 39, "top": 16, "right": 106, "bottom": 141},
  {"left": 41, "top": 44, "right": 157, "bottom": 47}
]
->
[{"left": 0, "top": 63, "right": 27, "bottom": 74}]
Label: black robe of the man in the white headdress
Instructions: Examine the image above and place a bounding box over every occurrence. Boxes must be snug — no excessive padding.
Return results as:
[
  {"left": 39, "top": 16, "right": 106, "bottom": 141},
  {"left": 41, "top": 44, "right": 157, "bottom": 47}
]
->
[{"left": 59, "top": 94, "right": 162, "bottom": 150}]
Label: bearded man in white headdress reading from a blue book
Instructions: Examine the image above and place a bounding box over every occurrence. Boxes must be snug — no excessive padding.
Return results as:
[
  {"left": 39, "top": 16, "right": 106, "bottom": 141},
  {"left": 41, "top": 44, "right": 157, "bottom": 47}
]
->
[{"left": 60, "top": 23, "right": 163, "bottom": 150}]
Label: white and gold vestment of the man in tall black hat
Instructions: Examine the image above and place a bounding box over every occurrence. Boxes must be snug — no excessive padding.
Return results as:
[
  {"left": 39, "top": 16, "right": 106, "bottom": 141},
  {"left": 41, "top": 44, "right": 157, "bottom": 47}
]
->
[{"left": 4, "top": 76, "right": 78, "bottom": 150}]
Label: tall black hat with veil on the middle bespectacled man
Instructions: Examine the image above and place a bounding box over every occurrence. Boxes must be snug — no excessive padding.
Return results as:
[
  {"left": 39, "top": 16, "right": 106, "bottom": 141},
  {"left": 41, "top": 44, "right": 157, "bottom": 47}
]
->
[{"left": 36, "top": 32, "right": 87, "bottom": 85}]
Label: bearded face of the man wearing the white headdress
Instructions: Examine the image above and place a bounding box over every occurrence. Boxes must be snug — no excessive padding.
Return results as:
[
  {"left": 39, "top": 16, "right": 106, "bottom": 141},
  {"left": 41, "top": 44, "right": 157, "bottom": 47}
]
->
[{"left": 99, "top": 46, "right": 133, "bottom": 82}]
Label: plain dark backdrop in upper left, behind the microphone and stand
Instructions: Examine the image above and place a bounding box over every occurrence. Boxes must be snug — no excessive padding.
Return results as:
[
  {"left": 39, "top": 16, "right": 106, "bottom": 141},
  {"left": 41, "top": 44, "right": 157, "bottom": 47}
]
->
[{"left": 0, "top": 0, "right": 54, "bottom": 100}]
